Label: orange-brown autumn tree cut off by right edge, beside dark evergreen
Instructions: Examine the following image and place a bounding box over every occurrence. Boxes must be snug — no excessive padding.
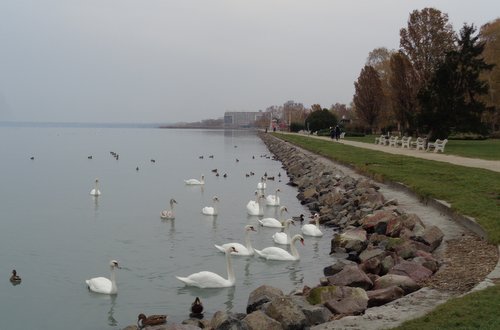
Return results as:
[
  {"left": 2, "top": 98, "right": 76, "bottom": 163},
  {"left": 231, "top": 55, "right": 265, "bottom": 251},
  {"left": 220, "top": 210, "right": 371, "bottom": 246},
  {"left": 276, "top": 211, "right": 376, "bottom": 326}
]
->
[{"left": 479, "top": 18, "right": 500, "bottom": 131}]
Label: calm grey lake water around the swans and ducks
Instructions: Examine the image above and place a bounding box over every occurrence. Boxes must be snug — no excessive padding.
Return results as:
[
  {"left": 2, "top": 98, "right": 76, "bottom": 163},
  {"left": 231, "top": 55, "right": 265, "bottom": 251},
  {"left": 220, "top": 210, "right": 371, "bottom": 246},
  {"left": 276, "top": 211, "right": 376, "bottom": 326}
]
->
[{"left": 0, "top": 127, "right": 332, "bottom": 329}]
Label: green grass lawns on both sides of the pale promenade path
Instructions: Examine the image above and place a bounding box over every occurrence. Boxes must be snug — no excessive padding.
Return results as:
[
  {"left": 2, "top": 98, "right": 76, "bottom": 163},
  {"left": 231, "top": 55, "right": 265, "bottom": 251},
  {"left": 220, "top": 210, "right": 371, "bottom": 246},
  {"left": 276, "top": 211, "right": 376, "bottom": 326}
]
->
[{"left": 276, "top": 134, "right": 500, "bottom": 330}]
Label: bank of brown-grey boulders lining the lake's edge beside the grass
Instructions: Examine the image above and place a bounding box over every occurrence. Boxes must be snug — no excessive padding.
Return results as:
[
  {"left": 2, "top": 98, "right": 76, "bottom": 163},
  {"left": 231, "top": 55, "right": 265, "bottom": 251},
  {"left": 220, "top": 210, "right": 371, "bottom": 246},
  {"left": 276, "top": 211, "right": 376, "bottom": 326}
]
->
[{"left": 126, "top": 133, "right": 496, "bottom": 330}]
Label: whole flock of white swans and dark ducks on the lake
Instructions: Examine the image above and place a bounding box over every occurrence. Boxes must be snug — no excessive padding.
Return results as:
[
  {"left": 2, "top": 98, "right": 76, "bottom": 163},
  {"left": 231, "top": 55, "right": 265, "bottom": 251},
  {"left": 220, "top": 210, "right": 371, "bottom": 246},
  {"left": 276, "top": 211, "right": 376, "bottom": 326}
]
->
[{"left": 25, "top": 150, "right": 323, "bottom": 328}]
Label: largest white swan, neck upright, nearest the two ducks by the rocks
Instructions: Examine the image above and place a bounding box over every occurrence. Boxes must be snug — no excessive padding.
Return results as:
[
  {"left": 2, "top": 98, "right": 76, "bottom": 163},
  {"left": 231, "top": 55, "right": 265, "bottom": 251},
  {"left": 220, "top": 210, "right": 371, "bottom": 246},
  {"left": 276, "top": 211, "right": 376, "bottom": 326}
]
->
[{"left": 176, "top": 246, "right": 238, "bottom": 289}]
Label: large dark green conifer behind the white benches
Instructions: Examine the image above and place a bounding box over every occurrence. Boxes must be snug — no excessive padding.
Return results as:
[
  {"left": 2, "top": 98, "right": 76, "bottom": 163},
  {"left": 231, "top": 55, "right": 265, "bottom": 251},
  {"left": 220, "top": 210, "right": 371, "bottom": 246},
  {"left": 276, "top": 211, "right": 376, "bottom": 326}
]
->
[{"left": 419, "top": 24, "right": 493, "bottom": 139}]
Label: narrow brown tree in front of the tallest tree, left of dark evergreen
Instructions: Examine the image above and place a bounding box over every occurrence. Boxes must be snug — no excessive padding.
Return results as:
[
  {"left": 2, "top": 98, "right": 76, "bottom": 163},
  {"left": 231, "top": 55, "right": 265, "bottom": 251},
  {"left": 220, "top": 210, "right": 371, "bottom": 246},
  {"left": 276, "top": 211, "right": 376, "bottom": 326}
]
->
[{"left": 389, "top": 52, "right": 418, "bottom": 132}]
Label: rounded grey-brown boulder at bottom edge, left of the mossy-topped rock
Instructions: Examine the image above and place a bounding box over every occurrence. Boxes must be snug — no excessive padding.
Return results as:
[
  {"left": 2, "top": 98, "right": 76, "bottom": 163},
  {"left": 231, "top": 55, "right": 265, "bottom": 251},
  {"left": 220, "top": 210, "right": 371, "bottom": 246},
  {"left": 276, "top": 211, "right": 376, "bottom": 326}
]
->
[{"left": 264, "top": 297, "right": 307, "bottom": 330}]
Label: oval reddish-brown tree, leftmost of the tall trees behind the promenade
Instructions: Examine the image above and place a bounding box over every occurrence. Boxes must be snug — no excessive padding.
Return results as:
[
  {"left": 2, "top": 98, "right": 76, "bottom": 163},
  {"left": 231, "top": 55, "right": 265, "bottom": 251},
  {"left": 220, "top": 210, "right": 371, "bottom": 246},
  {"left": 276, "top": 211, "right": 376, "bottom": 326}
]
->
[{"left": 353, "top": 65, "right": 383, "bottom": 132}]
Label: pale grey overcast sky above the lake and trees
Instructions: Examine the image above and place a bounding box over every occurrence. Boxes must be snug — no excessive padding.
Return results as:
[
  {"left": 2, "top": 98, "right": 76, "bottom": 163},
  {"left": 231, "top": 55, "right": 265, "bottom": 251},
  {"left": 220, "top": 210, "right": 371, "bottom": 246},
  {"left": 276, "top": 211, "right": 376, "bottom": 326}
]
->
[{"left": 0, "top": 0, "right": 500, "bottom": 123}]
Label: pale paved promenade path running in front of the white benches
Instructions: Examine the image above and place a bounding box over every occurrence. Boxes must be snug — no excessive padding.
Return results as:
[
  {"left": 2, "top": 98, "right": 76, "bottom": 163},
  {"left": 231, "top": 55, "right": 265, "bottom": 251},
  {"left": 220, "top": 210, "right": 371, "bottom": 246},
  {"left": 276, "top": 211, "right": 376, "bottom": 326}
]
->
[{"left": 286, "top": 135, "right": 500, "bottom": 172}]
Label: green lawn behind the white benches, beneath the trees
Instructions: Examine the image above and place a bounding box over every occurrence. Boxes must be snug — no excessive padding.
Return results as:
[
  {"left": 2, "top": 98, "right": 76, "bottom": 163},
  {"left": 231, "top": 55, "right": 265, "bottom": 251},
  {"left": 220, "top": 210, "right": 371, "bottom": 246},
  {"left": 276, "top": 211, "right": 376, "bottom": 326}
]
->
[{"left": 346, "top": 135, "right": 500, "bottom": 160}]
